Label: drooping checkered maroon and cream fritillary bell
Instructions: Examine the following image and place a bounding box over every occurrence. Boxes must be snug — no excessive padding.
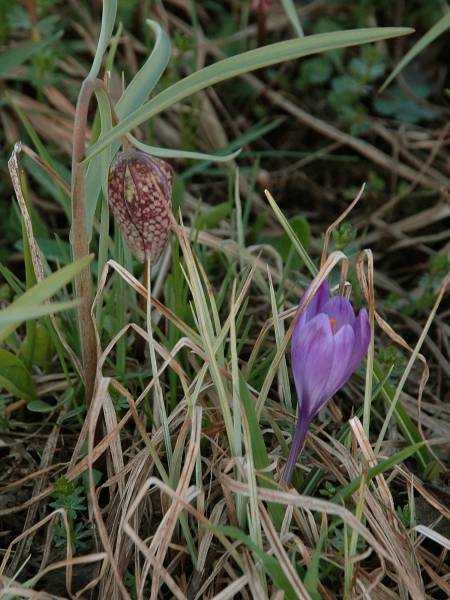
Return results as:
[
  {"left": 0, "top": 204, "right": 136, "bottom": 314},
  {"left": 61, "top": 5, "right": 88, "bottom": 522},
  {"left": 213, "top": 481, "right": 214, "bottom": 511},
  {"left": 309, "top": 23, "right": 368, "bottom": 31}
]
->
[{"left": 108, "top": 150, "right": 173, "bottom": 263}]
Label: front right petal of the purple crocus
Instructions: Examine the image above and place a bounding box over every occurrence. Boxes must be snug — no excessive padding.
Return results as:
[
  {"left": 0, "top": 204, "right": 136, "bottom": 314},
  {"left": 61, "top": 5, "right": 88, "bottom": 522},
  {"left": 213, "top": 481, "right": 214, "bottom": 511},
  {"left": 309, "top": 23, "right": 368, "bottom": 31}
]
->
[{"left": 316, "top": 325, "right": 355, "bottom": 412}]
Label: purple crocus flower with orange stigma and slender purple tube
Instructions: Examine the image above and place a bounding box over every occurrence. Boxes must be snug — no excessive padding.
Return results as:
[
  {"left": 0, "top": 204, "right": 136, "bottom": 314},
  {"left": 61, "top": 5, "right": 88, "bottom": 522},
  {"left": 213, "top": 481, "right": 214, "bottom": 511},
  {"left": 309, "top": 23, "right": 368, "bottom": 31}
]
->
[{"left": 283, "top": 281, "right": 370, "bottom": 482}]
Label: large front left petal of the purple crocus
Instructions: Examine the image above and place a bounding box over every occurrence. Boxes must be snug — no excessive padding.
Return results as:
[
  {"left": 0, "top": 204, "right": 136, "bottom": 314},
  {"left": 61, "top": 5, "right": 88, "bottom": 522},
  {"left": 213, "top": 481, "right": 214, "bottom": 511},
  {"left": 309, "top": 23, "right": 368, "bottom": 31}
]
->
[{"left": 291, "top": 314, "right": 334, "bottom": 418}]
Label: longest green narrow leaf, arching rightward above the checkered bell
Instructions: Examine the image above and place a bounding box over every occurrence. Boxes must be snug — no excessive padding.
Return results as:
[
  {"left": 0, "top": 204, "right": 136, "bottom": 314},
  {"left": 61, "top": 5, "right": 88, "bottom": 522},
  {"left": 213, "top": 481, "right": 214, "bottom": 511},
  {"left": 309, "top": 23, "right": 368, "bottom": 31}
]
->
[{"left": 86, "top": 27, "right": 413, "bottom": 160}]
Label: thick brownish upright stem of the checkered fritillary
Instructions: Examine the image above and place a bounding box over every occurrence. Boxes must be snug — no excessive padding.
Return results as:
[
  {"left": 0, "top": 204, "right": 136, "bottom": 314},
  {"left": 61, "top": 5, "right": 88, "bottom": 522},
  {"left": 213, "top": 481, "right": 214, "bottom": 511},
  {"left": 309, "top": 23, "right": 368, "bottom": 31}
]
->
[{"left": 70, "top": 79, "right": 104, "bottom": 404}]
